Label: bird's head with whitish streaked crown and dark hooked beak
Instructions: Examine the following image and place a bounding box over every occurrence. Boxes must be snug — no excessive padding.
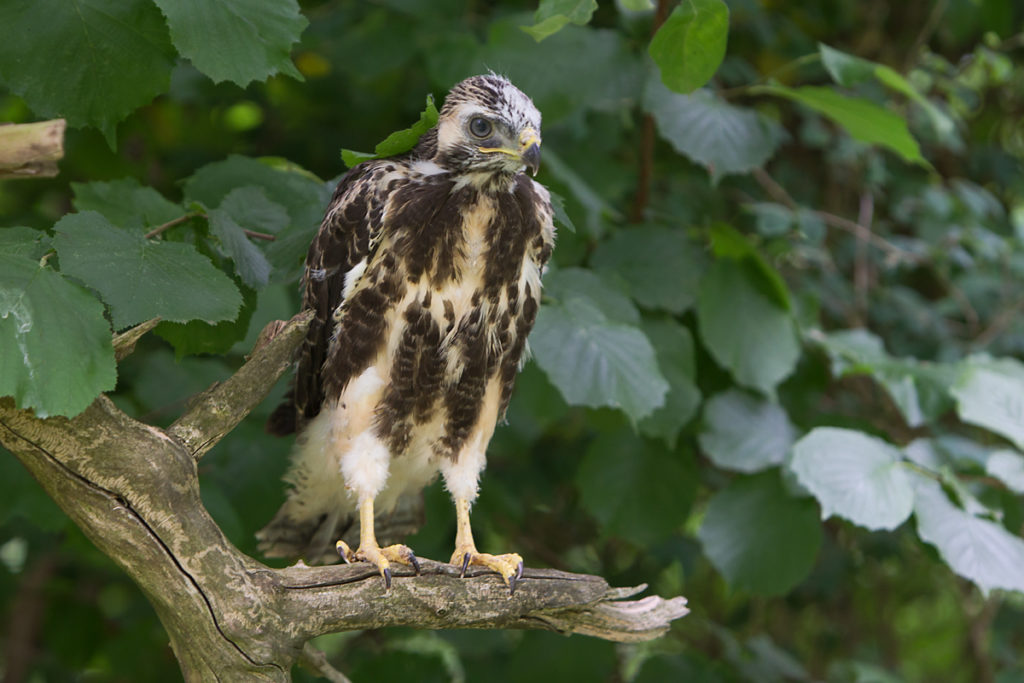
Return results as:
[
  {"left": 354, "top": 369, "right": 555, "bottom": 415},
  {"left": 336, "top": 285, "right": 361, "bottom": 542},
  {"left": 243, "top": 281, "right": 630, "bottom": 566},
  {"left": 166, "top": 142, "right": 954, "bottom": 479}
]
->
[{"left": 437, "top": 74, "right": 541, "bottom": 181}]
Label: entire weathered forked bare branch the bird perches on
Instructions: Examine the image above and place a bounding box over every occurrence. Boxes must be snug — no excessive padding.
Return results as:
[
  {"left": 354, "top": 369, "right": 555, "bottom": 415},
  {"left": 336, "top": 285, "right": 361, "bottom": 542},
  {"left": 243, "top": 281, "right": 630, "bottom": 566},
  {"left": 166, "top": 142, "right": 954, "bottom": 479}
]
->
[{"left": 0, "top": 314, "right": 688, "bottom": 681}]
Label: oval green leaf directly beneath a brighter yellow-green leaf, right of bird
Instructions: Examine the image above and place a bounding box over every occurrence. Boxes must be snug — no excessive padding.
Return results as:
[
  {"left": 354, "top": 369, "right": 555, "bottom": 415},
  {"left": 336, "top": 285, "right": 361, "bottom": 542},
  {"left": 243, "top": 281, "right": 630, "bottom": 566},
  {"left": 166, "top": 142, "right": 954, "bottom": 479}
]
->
[{"left": 697, "top": 260, "right": 800, "bottom": 395}]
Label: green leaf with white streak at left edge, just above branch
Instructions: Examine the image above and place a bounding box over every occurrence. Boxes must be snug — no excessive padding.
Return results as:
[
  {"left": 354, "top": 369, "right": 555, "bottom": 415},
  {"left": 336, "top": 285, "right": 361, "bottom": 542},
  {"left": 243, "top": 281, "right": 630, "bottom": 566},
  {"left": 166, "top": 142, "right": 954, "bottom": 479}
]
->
[{"left": 0, "top": 253, "right": 117, "bottom": 418}]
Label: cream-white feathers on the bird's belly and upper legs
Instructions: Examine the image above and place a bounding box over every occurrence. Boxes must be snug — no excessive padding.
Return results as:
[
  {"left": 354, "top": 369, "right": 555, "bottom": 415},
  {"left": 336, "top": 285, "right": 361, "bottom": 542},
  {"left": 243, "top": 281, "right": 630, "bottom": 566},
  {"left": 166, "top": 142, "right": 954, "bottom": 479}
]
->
[{"left": 276, "top": 192, "right": 541, "bottom": 514}]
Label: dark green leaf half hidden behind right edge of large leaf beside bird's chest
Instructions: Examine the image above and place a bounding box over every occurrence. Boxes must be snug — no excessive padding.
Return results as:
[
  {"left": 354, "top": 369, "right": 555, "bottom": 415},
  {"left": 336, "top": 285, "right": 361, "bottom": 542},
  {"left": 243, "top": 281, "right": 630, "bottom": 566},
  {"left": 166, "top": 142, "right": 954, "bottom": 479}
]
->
[{"left": 638, "top": 318, "right": 700, "bottom": 449}]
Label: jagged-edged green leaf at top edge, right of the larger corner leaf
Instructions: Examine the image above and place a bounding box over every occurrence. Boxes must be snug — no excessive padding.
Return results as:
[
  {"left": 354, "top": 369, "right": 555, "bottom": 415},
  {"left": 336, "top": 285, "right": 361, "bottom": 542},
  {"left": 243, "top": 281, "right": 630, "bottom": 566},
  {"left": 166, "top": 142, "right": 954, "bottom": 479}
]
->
[{"left": 149, "top": 0, "right": 309, "bottom": 88}]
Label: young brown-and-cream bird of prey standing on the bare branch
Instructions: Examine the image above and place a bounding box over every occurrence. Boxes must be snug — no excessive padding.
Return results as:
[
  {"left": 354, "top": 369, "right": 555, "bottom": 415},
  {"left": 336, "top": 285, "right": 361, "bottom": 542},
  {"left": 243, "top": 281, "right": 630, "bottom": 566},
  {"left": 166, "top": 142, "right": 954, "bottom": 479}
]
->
[{"left": 258, "top": 74, "right": 555, "bottom": 592}]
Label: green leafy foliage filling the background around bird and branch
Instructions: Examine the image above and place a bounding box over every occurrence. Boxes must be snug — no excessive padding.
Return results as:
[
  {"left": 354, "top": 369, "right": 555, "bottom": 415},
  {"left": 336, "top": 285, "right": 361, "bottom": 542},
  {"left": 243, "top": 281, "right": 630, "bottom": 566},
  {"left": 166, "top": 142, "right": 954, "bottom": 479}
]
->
[{"left": 6, "top": 0, "right": 1024, "bottom": 683}]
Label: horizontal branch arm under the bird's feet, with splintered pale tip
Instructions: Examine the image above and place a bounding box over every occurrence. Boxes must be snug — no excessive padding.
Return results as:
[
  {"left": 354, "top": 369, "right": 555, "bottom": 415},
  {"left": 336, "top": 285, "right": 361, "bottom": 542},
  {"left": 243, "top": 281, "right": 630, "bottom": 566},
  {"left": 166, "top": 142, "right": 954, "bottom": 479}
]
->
[{"left": 278, "top": 559, "right": 689, "bottom": 641}]
